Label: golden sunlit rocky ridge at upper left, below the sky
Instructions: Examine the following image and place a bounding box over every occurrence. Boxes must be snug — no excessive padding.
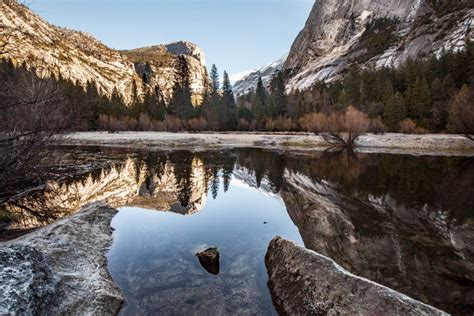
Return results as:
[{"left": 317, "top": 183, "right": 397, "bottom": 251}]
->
[{"left": 0, "top": 1, "right": 206, "bottom": 103}]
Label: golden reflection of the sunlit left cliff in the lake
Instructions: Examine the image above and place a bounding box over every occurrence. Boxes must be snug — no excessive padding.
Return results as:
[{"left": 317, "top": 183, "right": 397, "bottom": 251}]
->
[{"left": 2, "top": 158, "right": 207, "bottom": 229}]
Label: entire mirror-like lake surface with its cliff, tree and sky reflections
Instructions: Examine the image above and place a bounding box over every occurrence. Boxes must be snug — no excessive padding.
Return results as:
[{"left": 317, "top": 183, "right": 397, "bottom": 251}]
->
[{"left": 3, "top": 149, "right": 474, "bottom": 314}]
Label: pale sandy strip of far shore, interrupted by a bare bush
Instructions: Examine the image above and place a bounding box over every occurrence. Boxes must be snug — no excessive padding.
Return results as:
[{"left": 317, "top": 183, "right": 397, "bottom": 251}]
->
[{"left": 62, "top": 132, "right": 474, "bottom": 156}]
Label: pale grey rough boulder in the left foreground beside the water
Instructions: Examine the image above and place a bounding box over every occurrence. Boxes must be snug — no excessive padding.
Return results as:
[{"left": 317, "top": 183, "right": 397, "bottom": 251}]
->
[{"left": 0, "top": 203, "right": 124, "bottom": 315}]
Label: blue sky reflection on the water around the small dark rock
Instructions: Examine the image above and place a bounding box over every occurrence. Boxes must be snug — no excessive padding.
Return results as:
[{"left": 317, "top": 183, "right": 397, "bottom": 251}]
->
[{"left": 108, "top": 179, "right": 302, "bottom": 315}]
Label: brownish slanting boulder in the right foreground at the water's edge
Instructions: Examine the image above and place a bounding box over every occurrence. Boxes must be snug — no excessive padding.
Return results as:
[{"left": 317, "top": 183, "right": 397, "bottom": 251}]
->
[{"left": 265, "top": 237, "right": 447, "bottom": 315}]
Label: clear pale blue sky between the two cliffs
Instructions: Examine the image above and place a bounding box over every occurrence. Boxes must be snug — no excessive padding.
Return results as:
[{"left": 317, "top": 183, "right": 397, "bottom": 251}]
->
[{"left": 26, "top": 0, "right": 314, "bottom": 81}]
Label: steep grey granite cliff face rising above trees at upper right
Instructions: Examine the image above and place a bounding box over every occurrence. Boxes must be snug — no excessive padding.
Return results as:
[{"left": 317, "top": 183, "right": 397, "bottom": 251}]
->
[{"left": 283, "top": 0, "right": 474, "bottom": 90}]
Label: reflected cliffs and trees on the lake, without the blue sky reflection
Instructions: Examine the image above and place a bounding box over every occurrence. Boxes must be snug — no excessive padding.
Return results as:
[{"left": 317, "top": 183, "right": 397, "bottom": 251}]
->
[{"left": 2, "top": 149, "right": 474, "bottom": 313}]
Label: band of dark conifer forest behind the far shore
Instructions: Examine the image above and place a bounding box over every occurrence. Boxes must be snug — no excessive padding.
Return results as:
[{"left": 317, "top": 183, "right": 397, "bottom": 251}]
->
[{"left": 1, "top": 43, "right": 474, "bottom": 133}]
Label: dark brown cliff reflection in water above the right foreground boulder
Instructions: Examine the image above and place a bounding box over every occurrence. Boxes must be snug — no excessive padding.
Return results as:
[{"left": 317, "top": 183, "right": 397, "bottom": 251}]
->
[{"left": 281, "top": 171, "right": 474, "bottom": 314}]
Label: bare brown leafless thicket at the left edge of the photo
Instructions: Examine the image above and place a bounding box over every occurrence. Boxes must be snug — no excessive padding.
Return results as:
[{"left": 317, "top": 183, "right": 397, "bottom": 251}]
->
[{"left": 0, "top": 63, "right": 69, "bottom": 196}]
